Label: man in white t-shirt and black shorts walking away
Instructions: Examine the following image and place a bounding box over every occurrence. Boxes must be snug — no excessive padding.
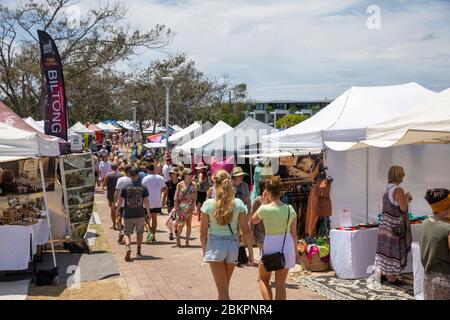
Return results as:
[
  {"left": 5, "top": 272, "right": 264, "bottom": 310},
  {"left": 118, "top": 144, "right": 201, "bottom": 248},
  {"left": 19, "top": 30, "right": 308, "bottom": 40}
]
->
[{"left": 142, "top": 164, "right": 166, "bottom": 243}]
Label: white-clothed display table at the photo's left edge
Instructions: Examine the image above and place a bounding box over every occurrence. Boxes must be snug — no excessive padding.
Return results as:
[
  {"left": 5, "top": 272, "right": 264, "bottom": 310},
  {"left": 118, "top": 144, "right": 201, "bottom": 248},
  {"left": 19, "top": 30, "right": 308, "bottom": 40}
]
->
[{"left": 0, "top": 219, "right": 50, "bottom": 271}]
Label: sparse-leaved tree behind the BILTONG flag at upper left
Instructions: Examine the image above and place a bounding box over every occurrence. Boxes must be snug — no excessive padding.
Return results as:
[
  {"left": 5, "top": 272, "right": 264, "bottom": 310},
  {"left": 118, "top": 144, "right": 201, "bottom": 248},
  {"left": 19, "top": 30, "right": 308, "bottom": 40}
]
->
[{"left": 0, "top": 0, "right": 173, "bottom": 118}]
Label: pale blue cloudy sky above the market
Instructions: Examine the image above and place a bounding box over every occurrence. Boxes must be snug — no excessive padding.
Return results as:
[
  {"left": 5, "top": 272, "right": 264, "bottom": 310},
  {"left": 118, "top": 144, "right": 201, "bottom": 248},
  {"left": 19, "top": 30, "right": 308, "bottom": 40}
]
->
[{"left": 0, "top": 0, "right": 450, "bottom": 99}]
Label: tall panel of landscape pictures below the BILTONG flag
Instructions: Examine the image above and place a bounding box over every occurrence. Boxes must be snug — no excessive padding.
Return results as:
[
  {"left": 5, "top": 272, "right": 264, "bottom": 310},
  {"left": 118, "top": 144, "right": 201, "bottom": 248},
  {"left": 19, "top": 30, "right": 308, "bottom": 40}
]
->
[{"left": 61, "top": 153, "right": 95, "bottom": 242}]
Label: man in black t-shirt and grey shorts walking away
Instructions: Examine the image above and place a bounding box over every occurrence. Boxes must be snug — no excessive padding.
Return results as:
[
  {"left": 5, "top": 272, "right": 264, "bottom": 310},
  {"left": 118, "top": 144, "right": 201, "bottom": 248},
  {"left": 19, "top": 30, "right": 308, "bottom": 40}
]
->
[{"left": 120, "top": 168, "right": 150, "bottom": 262}]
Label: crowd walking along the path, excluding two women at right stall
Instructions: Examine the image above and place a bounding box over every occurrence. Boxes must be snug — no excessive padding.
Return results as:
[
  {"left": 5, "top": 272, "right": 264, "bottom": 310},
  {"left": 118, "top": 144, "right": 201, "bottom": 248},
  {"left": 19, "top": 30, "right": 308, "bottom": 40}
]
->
[{"left": 89, "top": 143, "right": 298, "bottom": 299}]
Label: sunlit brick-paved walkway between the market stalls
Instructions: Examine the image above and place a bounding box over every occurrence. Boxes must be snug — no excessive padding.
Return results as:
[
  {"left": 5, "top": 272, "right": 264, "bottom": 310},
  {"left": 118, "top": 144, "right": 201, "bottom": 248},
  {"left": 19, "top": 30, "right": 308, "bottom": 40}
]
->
[{"left": 95, "top": 193, "right": 325, "bottom": 300}]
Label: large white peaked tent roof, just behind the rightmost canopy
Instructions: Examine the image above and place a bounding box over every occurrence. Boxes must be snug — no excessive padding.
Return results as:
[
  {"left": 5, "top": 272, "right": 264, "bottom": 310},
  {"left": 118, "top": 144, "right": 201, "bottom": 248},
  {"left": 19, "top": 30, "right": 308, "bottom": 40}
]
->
[{"left": 262, "top": 82, "right": 436, "bottom": 150}]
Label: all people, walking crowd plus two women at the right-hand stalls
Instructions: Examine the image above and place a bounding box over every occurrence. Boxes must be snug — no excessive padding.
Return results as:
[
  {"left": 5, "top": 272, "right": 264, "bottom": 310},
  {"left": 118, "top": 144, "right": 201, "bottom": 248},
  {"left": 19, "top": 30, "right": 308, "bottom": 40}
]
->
[{"left": 89, "top": 140, "right": 450, "bottom": 300}]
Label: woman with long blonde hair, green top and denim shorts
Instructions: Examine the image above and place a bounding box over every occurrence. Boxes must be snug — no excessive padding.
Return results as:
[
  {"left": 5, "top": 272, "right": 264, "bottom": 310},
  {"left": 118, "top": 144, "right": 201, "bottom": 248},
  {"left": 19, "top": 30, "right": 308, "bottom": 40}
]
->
[{"left": 200, "top": 170, "right": 254, "bottom": 300}]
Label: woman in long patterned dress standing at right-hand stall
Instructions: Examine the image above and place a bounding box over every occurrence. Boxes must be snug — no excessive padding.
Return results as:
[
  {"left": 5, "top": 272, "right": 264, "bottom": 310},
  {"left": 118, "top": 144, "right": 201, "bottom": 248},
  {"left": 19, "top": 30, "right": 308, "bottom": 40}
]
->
[{"left": 375, "top": 166, "right": 412, "bottom": 284}]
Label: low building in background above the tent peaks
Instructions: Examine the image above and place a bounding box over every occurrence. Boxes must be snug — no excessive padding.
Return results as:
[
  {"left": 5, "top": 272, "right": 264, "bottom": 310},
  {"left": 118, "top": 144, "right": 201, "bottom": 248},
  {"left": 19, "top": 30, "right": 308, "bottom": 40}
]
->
[{"left": 245, "top": 98, "right": 333, "bottom": 127}]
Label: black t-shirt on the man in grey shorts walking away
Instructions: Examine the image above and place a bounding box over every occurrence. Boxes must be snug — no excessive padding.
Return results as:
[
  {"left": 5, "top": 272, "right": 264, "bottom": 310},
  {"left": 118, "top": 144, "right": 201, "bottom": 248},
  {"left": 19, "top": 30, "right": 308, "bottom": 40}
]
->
[{"left": 120, "top": 180, "right": 148, "bottom": 219}]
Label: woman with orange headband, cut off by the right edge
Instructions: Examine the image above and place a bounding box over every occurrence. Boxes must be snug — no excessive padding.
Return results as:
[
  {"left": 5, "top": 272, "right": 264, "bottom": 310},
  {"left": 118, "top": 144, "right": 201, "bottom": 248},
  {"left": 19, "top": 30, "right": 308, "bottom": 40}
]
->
[{"left": 420, "top": 189, "right": 450, "bottom": 300}]
